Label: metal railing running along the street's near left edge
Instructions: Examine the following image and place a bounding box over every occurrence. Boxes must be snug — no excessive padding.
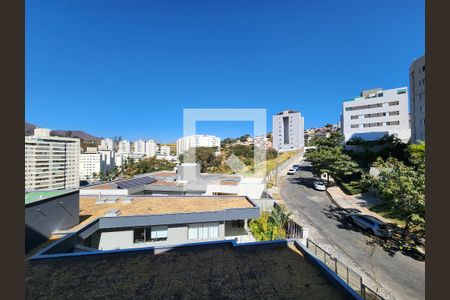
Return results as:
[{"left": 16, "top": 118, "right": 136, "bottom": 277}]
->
[{"left": 306, "top": 239, "right": 385, "bottom": 300}]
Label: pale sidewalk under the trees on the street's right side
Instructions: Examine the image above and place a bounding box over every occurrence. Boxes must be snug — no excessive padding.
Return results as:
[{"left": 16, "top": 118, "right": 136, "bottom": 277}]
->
[{"left": 327, "top": 186, "right": 392, "bottom": 223}]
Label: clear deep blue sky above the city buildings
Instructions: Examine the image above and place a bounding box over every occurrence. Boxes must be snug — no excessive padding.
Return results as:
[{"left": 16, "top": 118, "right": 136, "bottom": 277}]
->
[{"left": 25, "top": 0, "right": 425, "bottom": 142}]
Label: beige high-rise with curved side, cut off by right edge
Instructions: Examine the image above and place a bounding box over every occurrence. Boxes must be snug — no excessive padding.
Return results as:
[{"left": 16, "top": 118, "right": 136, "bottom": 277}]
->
[{"left": 409, "top": 55, "right": 425, "bottom": 142}]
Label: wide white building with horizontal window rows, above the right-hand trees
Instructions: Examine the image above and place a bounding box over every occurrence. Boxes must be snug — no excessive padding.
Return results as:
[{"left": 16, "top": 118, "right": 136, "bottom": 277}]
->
[{"left": 341, "top": 87, "right": 411, "bottom": 142}]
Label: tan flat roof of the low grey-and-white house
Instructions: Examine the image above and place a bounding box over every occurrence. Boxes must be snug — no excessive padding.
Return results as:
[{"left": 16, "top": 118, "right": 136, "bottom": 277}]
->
[{"left": 71, "top": 196, "right": 255, "bottom": 231}]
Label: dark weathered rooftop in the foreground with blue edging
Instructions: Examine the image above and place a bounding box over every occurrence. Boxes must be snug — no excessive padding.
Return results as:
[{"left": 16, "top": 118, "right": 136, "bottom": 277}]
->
[{"left": 25, "top": 243, "right": 346, "bottom": 299}]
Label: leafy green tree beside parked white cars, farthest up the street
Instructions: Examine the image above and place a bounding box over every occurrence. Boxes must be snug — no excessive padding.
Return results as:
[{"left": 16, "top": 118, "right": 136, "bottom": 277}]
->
[{"left": 306, "top": 147, "right": 359, "bottom": 184}]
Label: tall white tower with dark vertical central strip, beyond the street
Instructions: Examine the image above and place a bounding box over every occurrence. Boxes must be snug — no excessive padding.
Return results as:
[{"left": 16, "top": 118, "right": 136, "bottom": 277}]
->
[{"left": 272, "top": 110, "right": 305, "bottom": 151}]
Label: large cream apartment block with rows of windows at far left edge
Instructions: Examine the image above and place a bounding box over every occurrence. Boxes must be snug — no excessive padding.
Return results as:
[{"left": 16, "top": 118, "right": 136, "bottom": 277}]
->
[{"left": 25, "top": 128, "right": 80, "bottom": 191}]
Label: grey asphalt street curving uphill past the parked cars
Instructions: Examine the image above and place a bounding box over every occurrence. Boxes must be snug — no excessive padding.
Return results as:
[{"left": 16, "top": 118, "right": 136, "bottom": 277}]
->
[{"left": 281, "top": 162, "right": 425, "bottom": 299}]
